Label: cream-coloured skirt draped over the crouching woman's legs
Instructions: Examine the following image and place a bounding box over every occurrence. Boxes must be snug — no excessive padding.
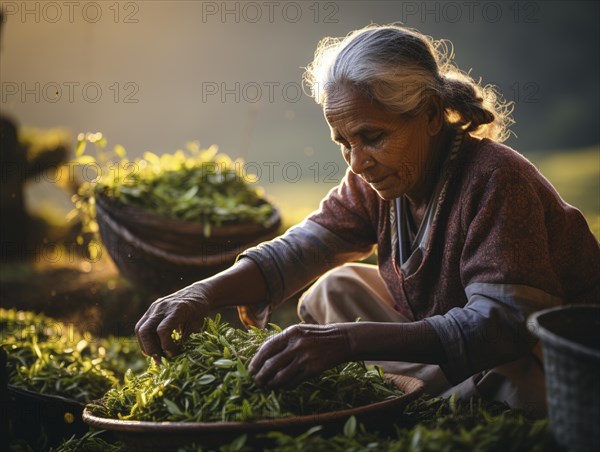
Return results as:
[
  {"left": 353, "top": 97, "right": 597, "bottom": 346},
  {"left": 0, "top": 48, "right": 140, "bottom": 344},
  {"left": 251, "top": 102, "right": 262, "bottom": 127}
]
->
[{"left": 298, "top": 264, "right": 547, "bottom": 417}]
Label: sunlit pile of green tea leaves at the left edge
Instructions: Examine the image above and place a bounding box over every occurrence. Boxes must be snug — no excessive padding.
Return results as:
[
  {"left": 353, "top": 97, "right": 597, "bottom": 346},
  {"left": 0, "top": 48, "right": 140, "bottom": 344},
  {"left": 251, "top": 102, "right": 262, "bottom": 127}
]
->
[{"left": 0, "top": 308, "right": 147, "bottom": 403}]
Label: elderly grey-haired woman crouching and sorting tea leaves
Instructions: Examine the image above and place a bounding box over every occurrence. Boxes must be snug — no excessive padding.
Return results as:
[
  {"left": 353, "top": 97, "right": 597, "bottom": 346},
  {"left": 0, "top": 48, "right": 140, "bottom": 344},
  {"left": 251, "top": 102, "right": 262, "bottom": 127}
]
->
[{"left": 136, "top": 26, "right": 600, "bottom": 413}]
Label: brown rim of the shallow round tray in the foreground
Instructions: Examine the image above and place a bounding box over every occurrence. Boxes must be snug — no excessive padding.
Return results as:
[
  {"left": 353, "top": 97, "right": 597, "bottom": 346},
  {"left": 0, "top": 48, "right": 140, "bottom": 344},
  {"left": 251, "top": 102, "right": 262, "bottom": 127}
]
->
[{"left": 83, "top": 374, "right": 424, "bottom": 433}]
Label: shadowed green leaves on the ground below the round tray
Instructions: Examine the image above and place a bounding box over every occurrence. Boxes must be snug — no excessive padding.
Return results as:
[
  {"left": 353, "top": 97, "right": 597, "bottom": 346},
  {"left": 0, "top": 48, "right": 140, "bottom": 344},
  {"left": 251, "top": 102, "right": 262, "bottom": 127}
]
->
[{"left": 69, "top": 396, "right": 561, "bottom": 452}]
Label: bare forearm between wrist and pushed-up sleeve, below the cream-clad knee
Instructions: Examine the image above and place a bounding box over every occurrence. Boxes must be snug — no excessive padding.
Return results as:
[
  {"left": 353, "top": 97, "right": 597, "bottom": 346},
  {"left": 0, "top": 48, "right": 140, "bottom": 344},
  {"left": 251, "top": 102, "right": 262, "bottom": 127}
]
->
[{"left": 340, "top": 320, "right": 446, "bottom": 364}]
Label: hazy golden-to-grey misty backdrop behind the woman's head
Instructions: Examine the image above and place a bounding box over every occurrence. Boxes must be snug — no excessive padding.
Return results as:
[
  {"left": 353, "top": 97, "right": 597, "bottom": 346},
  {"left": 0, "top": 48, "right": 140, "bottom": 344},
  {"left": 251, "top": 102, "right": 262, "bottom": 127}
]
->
[{"left": 0, "top": 0, "right": 600, "bottom": 207}]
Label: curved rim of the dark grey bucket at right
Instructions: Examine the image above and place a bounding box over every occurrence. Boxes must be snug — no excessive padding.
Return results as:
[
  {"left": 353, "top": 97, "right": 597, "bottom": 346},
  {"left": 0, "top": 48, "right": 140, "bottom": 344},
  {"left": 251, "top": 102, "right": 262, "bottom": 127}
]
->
[{"left": 527, "top": 304, "right": 600, "bottom": 359}]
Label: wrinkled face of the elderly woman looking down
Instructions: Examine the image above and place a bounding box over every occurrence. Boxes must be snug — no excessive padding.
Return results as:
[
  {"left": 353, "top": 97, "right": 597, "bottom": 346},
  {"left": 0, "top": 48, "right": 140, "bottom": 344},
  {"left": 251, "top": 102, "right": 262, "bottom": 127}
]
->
[{"left": 323, "top": 87, "right": 437, "bottom": 199}]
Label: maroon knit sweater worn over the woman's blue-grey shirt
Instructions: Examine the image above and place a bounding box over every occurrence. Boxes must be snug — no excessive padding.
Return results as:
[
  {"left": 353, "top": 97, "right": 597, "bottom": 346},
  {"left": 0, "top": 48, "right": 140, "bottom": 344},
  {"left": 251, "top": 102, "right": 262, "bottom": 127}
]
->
[{"left": 309, "top": 135, "right": 600, "bottom": 320}]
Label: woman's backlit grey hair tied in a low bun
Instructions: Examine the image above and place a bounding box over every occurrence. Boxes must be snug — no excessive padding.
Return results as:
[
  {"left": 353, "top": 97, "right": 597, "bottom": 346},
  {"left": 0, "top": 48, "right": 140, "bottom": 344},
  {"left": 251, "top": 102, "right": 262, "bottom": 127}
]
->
[{"left": 304, "top": 25, "right": 514, "bottom": 142}]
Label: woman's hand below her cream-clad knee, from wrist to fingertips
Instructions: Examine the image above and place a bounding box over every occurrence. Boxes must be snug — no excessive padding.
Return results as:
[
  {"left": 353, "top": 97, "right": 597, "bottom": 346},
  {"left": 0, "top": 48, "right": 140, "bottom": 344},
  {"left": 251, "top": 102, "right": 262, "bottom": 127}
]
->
[{"left": 248, "top": 324, "right": 351, "bottom": 387}]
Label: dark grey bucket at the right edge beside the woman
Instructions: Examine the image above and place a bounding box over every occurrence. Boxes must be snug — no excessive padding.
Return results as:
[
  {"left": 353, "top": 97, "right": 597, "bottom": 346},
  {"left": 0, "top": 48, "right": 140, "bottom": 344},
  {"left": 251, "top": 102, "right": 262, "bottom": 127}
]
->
[{"left": 528, "top": 305, "right": 600, "bottom": 451}]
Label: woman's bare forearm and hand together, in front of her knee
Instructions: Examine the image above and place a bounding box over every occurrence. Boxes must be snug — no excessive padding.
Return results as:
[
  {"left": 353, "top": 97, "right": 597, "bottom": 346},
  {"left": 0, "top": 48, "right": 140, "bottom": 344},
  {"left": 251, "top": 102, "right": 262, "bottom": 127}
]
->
[{"left": 248, "top": 320, "right": 446, "bottom": 387}]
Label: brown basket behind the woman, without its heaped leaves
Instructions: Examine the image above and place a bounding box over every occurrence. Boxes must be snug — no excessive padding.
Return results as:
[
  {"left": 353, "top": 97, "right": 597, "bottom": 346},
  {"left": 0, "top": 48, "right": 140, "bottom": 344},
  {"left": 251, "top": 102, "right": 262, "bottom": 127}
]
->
[{"left": 96, "top": 195, "right": 281, "bottom": 295}]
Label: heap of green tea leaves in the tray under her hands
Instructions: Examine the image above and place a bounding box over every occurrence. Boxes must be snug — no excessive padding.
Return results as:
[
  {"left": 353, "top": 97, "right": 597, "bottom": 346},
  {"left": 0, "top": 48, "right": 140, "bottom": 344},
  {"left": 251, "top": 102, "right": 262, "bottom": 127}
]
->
[{"left": 88, "top": 315, "right": 402, "bottom": 422}]
